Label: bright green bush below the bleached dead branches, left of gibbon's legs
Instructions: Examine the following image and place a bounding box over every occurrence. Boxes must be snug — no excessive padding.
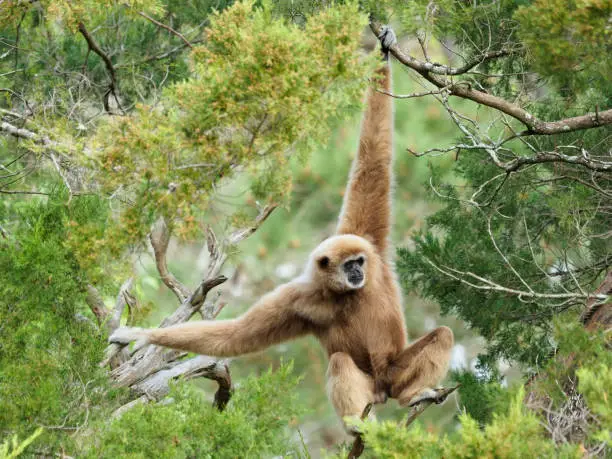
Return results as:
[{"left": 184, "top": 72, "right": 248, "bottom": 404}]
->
[{"left": 85, "top": 365, "right": 302, "bottom": 458}]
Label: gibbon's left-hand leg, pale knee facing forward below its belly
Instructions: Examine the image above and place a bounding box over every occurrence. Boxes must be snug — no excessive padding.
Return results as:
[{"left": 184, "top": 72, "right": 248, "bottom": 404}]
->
[{"left": 327, "top": 352, "right": 384, "bottom": 434}]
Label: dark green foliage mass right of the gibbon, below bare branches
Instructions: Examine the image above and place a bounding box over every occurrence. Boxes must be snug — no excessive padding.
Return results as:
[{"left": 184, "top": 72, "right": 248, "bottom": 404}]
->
[{"left": 398, "top": 144, "right": 610, "bottom": 366}]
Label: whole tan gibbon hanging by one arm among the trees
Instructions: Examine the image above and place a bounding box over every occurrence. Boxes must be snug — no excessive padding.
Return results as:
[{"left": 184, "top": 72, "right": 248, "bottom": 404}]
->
[{"left": 109, "top": 28, "right": 453, "bottom": 432}]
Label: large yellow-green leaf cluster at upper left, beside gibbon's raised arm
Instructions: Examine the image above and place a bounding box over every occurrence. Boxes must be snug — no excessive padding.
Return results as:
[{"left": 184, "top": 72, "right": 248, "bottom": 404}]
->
[{"left": 95, "top": 1, "right": 374, "bottom": 244}]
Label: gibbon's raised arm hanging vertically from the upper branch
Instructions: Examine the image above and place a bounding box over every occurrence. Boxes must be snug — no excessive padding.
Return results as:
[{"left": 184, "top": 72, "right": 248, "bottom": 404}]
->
[{"left": 337, "top": 28, "right": 395, "bottom": 259}]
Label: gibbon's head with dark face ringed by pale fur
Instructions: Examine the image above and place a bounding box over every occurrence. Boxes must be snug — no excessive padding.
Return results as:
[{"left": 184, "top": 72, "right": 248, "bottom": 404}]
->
[{"left": 312, "top": 234, "right": 373, "bottom": 293}]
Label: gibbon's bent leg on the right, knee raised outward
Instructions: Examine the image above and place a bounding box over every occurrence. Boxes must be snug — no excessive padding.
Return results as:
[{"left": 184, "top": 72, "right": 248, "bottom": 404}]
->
[{"left": 389, "top": 327, "right": 454, "bottom": 406}]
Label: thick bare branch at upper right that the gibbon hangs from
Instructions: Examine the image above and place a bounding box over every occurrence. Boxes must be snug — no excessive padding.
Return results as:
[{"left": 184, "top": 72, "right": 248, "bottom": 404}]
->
[{"left": 370, "top": 21, "right": 612, "bottom": 136}]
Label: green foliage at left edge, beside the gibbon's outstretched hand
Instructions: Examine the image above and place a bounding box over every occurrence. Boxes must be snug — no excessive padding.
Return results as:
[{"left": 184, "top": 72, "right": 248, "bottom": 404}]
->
[{"left": 0, "top": 195, "right": 126, "bottom": 450}]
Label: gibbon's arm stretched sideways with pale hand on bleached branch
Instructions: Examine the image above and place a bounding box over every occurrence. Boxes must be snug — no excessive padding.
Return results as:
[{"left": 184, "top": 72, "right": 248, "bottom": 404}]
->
[{"left": 109, "top": 282, "right": 310, "bottom": 357}]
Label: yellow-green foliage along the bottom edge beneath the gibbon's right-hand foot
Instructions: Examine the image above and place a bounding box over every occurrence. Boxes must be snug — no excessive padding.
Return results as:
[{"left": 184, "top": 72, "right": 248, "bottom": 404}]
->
[{"left": 338, "top": 390, "right": 581, "bottom": 459}]
